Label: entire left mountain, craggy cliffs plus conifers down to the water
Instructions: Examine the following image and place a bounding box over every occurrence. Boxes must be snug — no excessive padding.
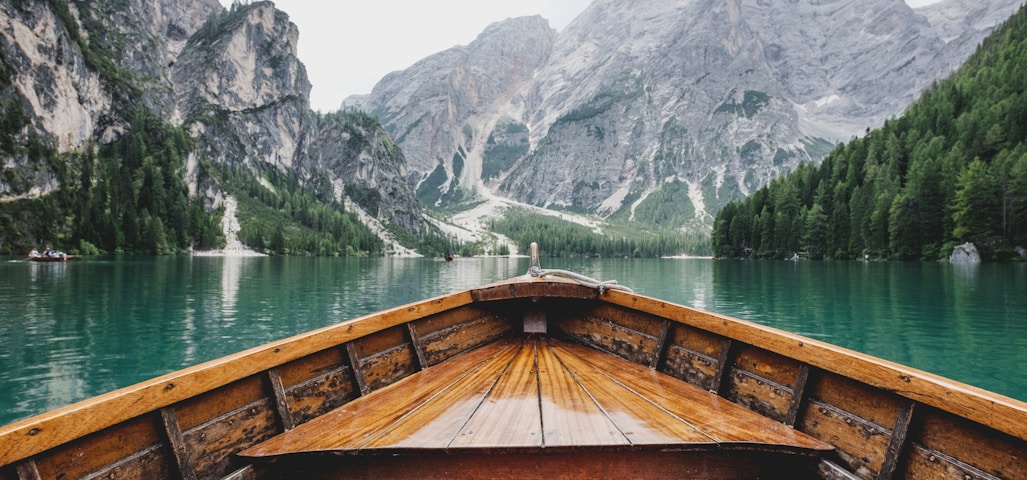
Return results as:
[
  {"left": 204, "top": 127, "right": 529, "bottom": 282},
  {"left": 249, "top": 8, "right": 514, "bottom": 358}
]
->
[{"left": 0, "top": 0, "right": 429, "bottom": 255}]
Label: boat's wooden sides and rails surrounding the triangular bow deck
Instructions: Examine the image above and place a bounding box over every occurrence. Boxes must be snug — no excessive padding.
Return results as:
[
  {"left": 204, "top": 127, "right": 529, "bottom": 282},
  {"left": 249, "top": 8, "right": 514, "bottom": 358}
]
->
[{"left": 0, "top": 279, "right": 1027, "bottom": 480}]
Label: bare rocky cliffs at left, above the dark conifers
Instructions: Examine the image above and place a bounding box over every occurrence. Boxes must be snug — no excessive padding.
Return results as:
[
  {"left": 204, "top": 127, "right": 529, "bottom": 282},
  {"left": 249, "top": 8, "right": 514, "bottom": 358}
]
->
[{"left": 0, "top": 0, "right": 422, "bottom": 244}]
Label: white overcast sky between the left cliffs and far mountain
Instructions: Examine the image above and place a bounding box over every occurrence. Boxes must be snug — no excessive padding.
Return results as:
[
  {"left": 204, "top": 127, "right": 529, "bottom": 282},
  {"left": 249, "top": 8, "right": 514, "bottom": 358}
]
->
[{"left": 221, "top": 0, "right": 944, "bottom": 112}]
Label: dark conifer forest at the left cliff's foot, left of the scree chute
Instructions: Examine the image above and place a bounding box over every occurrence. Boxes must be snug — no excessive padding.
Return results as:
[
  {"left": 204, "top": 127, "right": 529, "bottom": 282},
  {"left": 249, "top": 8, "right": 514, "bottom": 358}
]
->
[{"left": 0, "top": 109, "right": 224, "bottom": 255}]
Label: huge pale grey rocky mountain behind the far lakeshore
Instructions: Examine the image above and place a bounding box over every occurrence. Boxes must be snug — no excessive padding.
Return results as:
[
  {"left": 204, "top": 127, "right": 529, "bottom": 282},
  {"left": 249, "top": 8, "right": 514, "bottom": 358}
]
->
[{"left": 343, "top": 0, "right": 1020, "bottom": 233}]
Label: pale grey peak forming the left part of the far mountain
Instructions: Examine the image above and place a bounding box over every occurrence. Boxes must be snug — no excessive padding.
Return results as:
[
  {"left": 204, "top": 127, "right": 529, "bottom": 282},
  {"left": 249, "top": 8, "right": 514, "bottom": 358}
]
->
[{"left": 343, "top": 16, "right": 556, "bottom": 199}]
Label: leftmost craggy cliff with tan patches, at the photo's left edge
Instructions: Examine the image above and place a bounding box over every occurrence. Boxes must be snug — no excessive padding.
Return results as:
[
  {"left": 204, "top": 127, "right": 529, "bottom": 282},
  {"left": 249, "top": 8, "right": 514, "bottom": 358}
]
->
[{"left": 0, "top": 0, "right": 221, "bottom": 198}]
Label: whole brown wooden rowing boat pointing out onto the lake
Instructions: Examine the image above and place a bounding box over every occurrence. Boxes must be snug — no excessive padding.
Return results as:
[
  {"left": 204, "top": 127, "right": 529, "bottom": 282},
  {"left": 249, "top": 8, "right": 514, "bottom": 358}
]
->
[{"left": 0, "top": 247, "right": 1027, "bottom": 480}]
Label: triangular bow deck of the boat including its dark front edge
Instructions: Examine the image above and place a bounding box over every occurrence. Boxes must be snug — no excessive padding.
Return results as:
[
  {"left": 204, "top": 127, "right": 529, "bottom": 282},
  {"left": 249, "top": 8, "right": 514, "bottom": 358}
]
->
[{"left": 240, "top": 335, "right": 832, "bottom": 478}]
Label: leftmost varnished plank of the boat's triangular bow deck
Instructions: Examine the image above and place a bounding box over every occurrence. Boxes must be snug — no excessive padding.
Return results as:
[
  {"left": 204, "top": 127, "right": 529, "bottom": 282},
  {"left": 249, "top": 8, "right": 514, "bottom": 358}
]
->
[{"left": 239, "top": 343, "right": 514, "bottom": 456}]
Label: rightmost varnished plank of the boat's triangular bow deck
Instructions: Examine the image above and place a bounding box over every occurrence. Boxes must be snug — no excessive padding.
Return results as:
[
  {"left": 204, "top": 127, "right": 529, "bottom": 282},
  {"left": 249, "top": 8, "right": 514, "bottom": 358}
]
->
[{"left": 558, "top": 343, "right": 832, "bottom": 451}]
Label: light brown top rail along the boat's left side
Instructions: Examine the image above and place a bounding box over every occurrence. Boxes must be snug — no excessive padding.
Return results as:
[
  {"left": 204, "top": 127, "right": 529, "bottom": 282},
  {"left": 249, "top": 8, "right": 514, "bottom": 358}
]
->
[{"left": 0, "top": 291, "right": 472, "bottom": 465}]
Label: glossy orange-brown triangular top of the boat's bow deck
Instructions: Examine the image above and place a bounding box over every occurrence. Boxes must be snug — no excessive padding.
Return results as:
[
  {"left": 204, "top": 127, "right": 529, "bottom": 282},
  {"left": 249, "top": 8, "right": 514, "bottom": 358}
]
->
[{"left": 240, "top": 336, "right": 831, "bottom": 456}]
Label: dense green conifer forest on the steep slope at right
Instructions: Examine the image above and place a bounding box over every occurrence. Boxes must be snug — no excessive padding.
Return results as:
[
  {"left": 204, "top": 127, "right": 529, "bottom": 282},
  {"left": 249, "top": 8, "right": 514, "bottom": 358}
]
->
[{"left": 713, "top": 3, "right": 1027, "bottom": 260}]
